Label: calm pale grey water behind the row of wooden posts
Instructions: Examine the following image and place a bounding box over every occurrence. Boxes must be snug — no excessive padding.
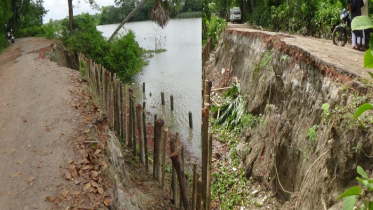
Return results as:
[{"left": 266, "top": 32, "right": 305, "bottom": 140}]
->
[{"left": 97, "top": 18, "right": 202, "bottom": 159}]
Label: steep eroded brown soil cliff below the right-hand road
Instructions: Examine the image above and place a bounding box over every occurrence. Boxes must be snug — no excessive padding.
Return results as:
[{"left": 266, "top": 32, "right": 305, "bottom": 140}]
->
[{"left": 206, "top": 30, "right": 373, "bottom": 209}]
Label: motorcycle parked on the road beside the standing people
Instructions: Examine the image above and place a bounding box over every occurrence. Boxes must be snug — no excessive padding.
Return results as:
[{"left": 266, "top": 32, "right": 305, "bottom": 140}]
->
[{"left": 332, "top": 9, "right": 351, "bottom": 47}]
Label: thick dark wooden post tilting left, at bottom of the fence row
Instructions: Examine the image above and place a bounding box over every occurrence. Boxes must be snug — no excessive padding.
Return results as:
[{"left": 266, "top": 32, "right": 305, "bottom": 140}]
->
[{"left": 170, "top": 153, "right": 189, "bottom": 210}]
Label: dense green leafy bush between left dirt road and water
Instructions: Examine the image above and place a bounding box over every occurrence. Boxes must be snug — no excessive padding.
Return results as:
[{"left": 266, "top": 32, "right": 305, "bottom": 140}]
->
[{"left": 62, "top": 14, "right": 145, "bottom": 81}]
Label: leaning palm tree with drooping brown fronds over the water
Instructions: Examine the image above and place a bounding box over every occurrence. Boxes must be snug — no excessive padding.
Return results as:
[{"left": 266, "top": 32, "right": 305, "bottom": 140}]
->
[{"left": 108, "top": 0, "right": 172, "bottom": 42}]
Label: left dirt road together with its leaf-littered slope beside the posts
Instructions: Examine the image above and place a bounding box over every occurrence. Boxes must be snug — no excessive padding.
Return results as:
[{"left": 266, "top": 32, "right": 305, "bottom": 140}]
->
[{"left": 0, "top": 38, "right": 172, "bottom": 210}]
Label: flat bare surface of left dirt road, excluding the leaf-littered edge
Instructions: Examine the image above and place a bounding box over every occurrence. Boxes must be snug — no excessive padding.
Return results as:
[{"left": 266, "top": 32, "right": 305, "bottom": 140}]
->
[{"left": 0, "top": 38, "right": 79, "bottom": 210}]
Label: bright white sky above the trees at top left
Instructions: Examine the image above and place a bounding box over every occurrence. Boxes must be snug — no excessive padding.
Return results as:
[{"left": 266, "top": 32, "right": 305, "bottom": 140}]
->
[{"left": 43, "top": 0, "right": 114, "bottom": 23}]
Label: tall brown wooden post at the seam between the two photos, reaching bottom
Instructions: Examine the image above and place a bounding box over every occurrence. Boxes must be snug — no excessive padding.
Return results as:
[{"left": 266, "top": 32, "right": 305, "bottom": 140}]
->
[{"left": 202, "top": 108, "right": 209, "bottom": 209}]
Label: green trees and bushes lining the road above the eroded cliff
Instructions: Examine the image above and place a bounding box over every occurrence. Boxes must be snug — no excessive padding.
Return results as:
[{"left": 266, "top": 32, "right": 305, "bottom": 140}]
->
[{"left": 202, "top": 0, "right": 373, "bottom": 38}]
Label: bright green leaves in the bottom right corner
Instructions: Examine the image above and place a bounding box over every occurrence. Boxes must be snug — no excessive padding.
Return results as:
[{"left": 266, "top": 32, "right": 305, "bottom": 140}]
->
[{"left": 338, "top": 166, "right": 373, "bottom": 210}]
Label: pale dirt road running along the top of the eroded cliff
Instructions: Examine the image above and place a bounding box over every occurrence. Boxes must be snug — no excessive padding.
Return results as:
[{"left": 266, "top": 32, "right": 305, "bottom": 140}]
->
[{"left": 227, "top": 23, "right": 371, "bottom": 78}]
